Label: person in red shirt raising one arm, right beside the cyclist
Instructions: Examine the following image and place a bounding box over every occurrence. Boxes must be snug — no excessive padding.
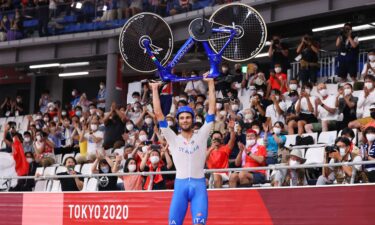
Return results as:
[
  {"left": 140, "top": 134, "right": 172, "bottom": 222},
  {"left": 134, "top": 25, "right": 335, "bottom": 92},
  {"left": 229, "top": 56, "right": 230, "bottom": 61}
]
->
[{"left": 206, "top": 120, "right": 236, "bottom": 188}]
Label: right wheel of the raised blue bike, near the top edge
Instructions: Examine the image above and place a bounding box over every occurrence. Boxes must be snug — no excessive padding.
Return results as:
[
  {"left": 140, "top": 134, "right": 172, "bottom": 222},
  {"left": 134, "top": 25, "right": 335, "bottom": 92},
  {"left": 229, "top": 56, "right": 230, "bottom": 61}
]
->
[{"left": 208, "top": 3, "right": 267, "bottom": 62}]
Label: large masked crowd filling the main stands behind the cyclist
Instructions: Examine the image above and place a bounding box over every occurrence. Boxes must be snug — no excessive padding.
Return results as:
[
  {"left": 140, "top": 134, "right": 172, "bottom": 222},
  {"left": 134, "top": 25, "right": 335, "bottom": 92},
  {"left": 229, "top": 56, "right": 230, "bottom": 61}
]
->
[{"left": 1, "top": 24, "right": 375, "bottom": 191}]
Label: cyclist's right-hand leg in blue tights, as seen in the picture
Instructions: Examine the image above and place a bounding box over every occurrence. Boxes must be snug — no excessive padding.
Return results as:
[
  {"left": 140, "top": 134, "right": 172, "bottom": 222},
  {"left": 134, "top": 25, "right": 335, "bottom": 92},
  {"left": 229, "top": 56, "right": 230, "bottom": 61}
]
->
[{"left": 189, "top": 178, "right": 208, "bottom": 225}]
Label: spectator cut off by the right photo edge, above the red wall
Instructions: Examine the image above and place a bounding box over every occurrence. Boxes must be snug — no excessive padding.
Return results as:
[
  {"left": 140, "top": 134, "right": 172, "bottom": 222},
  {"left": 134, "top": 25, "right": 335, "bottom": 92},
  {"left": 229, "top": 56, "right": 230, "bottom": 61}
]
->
[{"left": 361, "top": 126, "right": 375, "bottom": 183}]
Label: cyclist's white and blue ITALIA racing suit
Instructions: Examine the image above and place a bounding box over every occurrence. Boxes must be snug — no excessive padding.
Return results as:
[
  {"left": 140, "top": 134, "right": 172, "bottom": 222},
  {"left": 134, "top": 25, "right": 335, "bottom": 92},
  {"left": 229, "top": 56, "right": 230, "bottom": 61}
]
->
[{"left": 159, "top": 115, "right": 215, "bottom": 225}]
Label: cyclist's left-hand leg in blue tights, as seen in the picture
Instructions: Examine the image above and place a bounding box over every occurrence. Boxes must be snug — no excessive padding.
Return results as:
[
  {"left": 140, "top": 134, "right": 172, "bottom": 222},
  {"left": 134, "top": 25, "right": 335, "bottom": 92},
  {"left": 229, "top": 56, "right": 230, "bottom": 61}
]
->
[{"left": 169, "top": 179, "right": 189, "bottom": 225}]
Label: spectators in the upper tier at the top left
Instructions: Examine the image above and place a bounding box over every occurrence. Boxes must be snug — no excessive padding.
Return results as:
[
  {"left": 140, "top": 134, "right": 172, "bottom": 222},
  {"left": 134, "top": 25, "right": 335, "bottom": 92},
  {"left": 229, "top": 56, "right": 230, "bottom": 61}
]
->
[{"left": 0, "top": 0, "right": 232, "bottom": 42}]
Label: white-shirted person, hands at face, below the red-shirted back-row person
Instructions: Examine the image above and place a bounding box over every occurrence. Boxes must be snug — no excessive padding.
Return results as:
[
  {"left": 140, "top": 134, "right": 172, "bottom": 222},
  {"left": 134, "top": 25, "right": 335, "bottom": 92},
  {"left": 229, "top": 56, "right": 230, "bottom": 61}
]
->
[{"left": 266, "top": 90, "right": 287, "bottom": 128}]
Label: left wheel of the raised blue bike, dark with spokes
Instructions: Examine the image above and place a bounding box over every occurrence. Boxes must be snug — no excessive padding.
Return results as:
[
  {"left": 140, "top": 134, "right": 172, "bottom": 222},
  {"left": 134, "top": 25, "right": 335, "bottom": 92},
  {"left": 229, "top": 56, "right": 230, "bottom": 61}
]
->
[{"left": 119, "top": 13, "right": 173, "bottom": 73}]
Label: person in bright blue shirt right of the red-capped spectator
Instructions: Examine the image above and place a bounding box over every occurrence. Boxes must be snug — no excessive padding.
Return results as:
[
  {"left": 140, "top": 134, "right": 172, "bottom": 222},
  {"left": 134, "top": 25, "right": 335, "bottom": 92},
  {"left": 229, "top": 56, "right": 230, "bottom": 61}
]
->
[{"left": 263, "top": 121, "right": 286, "bottom": 165}]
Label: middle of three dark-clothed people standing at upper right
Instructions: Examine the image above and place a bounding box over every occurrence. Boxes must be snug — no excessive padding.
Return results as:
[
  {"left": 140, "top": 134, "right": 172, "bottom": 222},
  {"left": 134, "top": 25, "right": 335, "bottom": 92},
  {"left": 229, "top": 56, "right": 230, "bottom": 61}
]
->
[{"left": 297, "top": 35, "right": 320, "bottom": 84}]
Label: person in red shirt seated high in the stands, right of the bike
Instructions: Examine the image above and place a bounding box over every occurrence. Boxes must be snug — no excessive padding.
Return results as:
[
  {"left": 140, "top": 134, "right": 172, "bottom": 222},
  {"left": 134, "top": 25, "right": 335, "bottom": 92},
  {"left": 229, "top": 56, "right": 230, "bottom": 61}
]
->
[{"left": 267, "top": 64, "right": 288, "bottom": 96}]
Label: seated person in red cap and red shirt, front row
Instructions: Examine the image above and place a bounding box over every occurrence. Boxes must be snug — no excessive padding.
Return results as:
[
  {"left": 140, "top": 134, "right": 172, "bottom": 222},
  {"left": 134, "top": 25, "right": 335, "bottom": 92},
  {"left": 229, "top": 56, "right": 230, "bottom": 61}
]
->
[{"left": 229, "top": 129, "right": 267, "bottom": 188}]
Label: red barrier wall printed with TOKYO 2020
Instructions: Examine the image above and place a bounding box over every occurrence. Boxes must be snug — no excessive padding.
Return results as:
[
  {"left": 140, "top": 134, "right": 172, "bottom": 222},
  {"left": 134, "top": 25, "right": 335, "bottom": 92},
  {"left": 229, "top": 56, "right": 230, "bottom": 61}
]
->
[{"left": 0, "top": 185, "right": 375, "bottom": 225}]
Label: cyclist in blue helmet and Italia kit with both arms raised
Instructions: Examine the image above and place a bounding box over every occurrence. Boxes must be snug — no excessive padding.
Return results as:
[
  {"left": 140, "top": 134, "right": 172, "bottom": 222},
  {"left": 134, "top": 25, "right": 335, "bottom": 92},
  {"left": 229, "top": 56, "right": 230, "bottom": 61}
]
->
[{"left": 150, "top": 73, "right": 216, "bottom": 225}]
